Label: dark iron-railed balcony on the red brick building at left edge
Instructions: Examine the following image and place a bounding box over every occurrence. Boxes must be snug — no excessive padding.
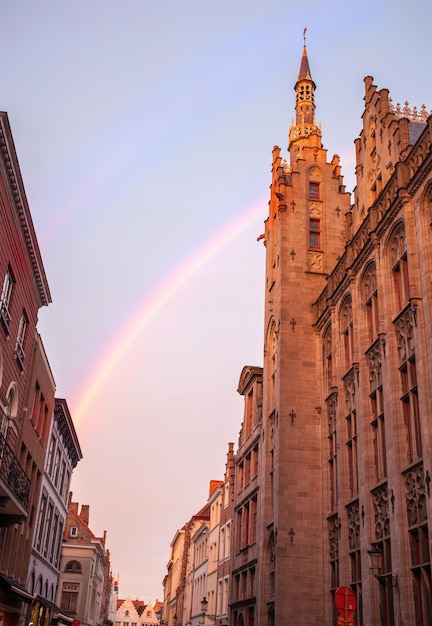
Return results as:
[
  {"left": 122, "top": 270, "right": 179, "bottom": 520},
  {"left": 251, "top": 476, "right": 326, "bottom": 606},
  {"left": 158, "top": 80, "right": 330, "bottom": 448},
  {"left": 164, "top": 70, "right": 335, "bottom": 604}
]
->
[{"left": 0, "top": 434, "right": 30, "bottom": 527}]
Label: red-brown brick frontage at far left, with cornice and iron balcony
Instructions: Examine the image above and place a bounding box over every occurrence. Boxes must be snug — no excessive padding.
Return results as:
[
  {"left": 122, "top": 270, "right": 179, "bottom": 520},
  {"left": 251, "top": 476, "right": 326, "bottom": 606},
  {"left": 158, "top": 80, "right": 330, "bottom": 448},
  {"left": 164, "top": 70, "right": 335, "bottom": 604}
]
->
[{"left": 0, "top": 113, "right": 54, "bottom": 626}]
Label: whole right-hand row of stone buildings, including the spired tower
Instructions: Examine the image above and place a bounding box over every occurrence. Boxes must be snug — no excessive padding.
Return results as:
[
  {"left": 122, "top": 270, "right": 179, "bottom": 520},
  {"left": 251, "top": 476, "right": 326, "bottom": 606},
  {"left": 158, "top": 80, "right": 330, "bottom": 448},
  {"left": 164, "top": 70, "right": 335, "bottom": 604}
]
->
[{"left": 163, "top": 45, "right": 432, "bottom": 626}]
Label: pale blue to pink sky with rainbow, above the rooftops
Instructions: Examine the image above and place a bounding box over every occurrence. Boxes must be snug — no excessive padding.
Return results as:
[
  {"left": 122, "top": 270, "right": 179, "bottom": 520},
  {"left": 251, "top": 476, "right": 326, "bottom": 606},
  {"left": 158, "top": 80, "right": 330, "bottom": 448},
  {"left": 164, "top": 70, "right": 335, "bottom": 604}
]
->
[{"left": 0, "top": 0, "right": 432, "bottom": 602}]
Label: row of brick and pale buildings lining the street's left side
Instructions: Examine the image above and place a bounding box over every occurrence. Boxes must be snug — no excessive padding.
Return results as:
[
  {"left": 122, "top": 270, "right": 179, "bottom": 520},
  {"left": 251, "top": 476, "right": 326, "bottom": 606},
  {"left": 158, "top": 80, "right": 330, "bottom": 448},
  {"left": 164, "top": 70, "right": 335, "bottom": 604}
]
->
[{"left": 0, "top": 113, "right": 111, "bottom": 626}]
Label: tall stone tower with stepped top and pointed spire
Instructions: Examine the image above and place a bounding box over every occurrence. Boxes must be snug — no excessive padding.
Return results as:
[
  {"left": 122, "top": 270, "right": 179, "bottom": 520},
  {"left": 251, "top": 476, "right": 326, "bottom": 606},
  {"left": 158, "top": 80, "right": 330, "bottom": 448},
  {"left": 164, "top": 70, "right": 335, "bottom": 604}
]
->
[{"left": 256, "top": 45, "right": 351, "bottom": 626}]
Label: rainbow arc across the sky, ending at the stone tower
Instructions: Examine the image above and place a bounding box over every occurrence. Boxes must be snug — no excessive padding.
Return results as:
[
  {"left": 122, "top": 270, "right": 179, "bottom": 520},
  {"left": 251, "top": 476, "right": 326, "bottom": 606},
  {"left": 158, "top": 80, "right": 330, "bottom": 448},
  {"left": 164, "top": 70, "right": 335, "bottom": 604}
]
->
[{"left": 72, "top": 201, "right": 266, "bottom": 424}]
